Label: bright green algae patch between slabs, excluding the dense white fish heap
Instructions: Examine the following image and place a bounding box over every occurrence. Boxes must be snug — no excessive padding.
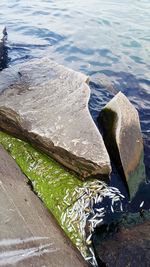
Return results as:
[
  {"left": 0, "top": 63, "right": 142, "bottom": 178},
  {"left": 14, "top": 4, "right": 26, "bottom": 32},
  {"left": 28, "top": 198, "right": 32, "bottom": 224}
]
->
[{"left": 0, "top": 131, "right": 90, "bottom": 255}]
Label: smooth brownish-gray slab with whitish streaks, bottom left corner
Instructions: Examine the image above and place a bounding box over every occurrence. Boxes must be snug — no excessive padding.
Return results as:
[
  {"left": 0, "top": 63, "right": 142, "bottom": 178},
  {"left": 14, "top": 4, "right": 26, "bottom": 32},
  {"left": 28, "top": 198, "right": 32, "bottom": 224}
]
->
[{"left": 0, "top": 146, "right": 87, "bottom": 267}]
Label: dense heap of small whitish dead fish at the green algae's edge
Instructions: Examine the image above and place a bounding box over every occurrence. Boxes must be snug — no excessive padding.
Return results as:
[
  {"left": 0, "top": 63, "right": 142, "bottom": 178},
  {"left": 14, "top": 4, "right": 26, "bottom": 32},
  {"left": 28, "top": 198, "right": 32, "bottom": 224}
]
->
[{"left": 62, "top": 179, "right": 124, "bottom": 266}]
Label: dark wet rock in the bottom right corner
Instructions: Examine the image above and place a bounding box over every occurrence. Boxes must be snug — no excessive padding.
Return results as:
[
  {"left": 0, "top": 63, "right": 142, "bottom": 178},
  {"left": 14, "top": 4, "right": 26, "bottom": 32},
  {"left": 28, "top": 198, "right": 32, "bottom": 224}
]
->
[{"left": 95, "top": 221, "right": 150, "bottom": 267}]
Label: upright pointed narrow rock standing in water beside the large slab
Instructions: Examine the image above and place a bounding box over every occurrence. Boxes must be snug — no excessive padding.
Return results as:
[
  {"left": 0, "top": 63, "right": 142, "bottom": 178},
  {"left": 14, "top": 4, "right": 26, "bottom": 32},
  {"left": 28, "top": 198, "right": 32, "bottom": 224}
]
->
[{"left": 99, "top": 92, "right": 145, "bottom": 198}]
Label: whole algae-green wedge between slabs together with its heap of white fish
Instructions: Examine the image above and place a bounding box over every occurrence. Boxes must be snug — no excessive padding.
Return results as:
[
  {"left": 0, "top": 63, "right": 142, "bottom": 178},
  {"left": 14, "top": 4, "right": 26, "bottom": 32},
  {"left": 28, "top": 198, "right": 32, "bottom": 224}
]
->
[{"left": 0, "top": 131, "right": 125, "bottom": 266}]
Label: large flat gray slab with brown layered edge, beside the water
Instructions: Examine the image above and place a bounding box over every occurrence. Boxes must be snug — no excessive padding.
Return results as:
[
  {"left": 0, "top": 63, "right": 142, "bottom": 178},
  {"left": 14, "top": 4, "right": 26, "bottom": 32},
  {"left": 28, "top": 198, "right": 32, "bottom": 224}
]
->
[{"left": 0, "top": 58, "right": 111, "bottom": 179}]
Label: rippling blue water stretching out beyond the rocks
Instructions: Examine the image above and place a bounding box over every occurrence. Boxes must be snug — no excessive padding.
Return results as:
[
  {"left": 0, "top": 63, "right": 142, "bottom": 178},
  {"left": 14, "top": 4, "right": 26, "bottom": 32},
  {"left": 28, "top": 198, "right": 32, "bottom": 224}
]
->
[{"left": 0, "top": 0, "right": 150, "bottom": 210}]
